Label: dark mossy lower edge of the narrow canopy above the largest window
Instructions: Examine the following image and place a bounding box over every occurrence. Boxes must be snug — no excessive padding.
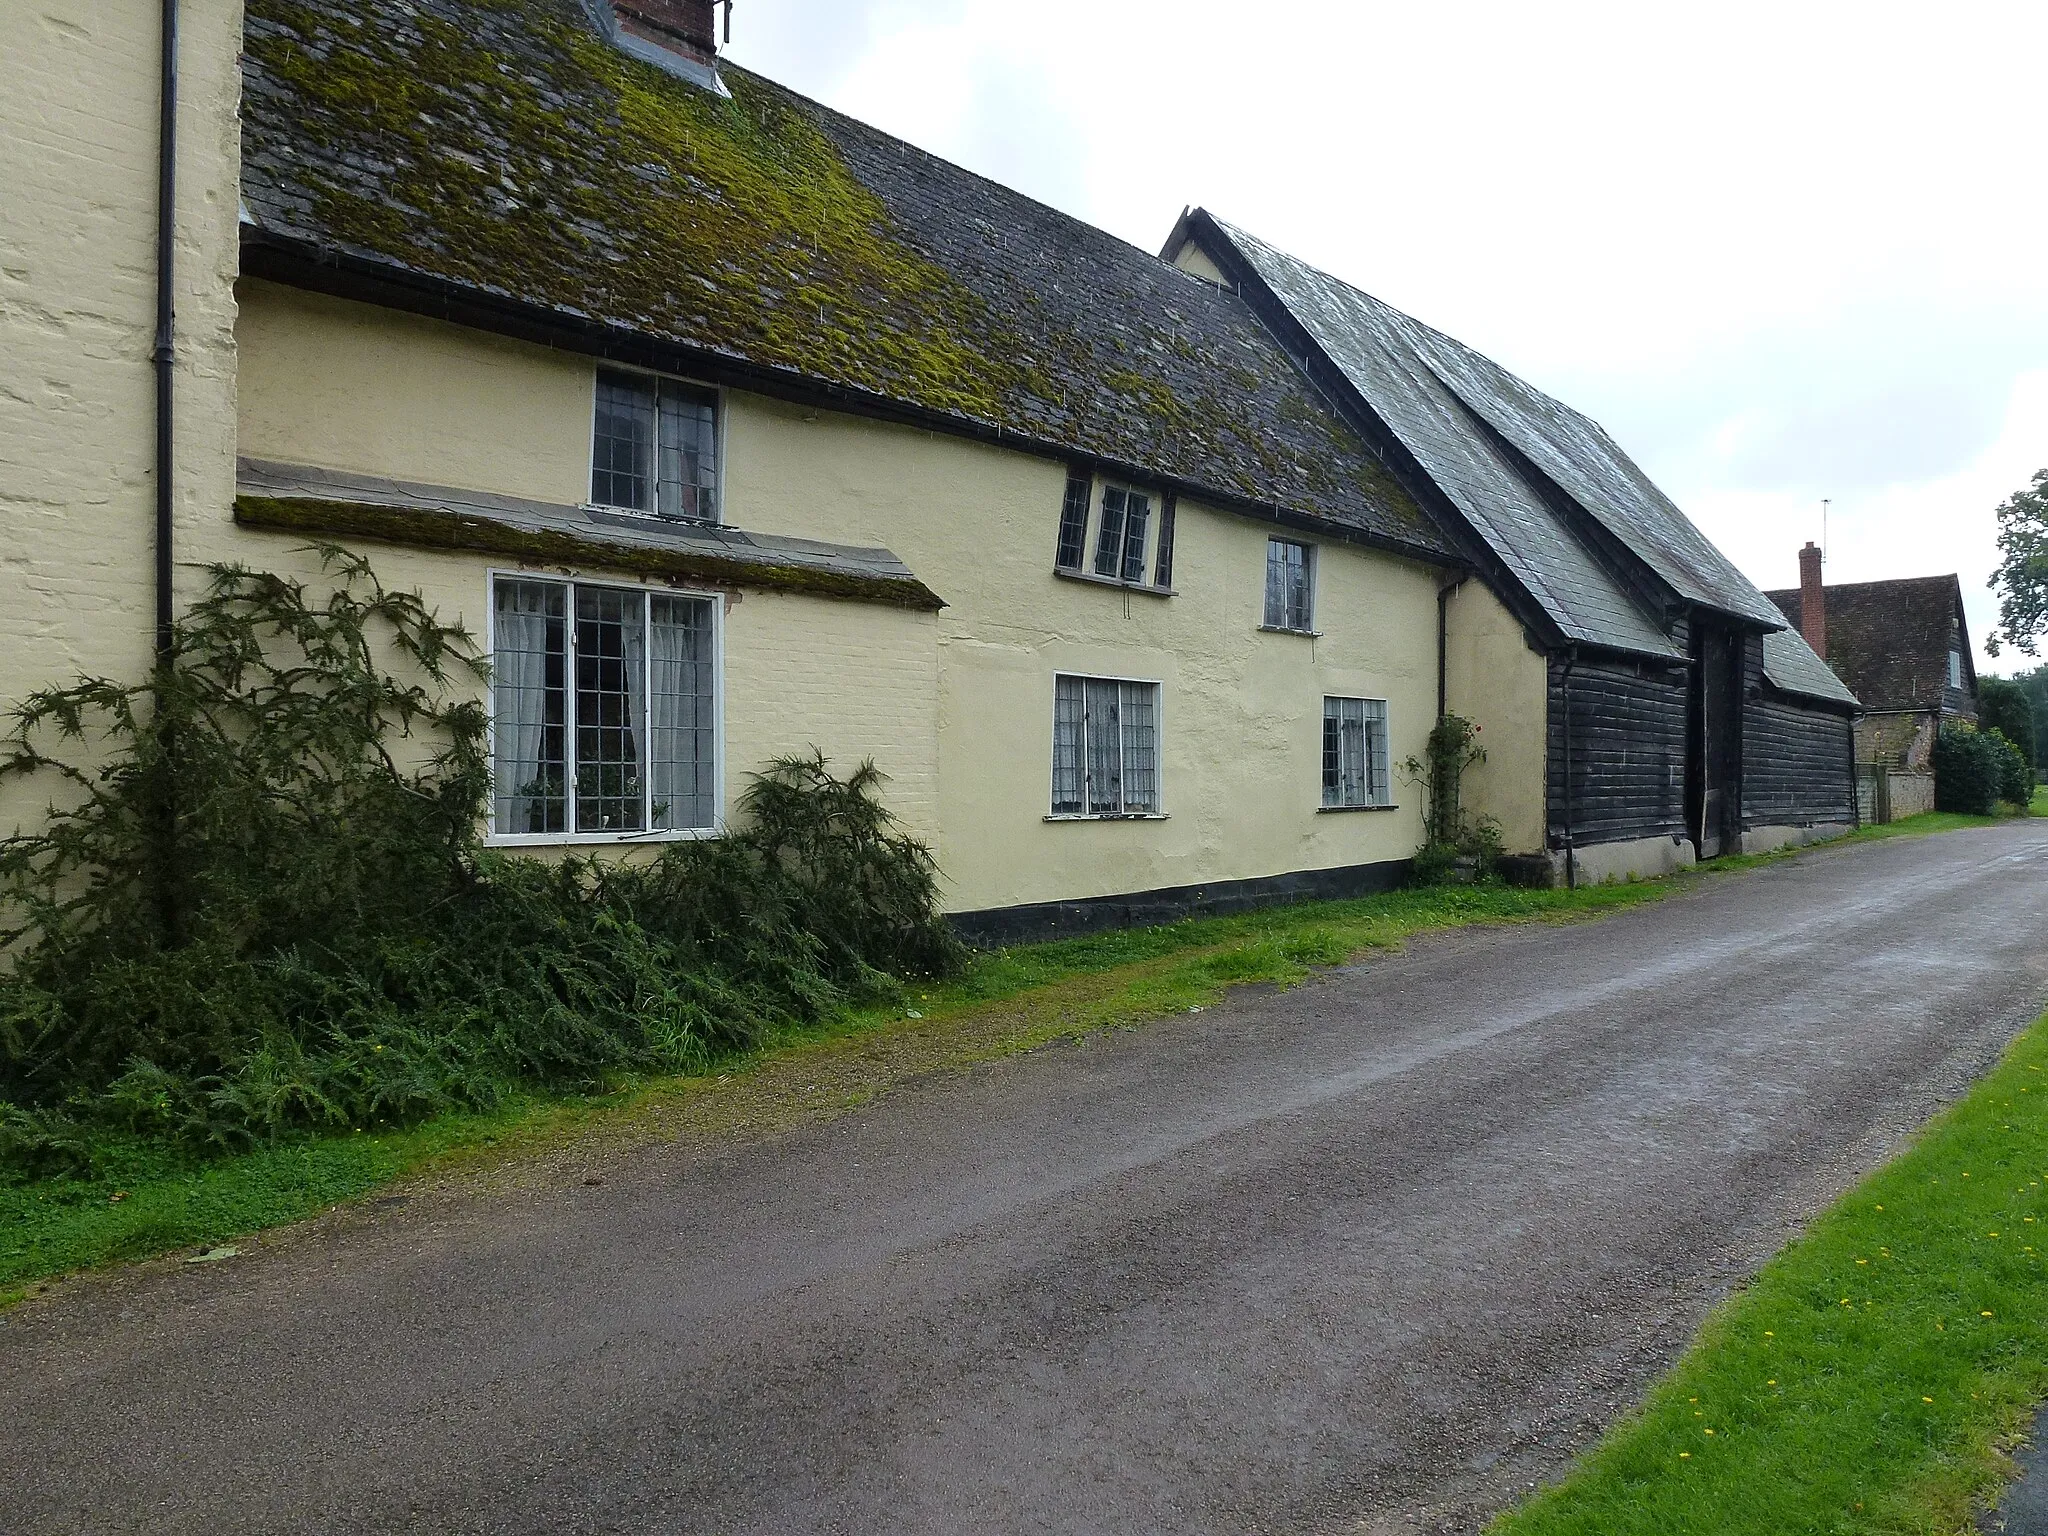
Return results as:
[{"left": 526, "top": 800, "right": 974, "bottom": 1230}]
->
[{"left": 236, "top": 496, "right": 946, "bottom": 612}]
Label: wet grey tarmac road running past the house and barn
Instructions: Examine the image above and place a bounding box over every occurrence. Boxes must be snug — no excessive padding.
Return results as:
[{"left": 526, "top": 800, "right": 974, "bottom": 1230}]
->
[{"left": 12, "top": 821, "right": 2048, "bottom": 1536}]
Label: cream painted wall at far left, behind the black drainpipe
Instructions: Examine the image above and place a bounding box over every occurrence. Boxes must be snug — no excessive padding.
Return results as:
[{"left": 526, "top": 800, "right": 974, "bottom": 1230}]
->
[{"left": 0, "top": 0, "right": 242, "bottom": 831}]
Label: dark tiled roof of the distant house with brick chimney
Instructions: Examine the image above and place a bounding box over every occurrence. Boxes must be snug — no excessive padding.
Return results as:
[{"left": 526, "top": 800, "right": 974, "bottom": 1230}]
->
[{"left": 1767, "top": 575, "right": 1968, "bottom": 709}]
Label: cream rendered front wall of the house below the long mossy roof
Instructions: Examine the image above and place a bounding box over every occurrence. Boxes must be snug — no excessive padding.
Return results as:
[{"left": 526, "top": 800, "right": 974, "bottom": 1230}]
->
[{"left": 240, "top": 283, "right": 1436, "bottom": 911}]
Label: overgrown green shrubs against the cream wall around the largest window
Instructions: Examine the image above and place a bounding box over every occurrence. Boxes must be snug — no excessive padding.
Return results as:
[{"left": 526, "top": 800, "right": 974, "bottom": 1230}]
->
[{"left": 0, "top": 549, "right": 961, "bottom": 1176}]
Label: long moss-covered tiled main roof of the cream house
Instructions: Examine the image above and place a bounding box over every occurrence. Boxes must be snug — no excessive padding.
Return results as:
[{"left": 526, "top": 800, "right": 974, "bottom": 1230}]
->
[{"left": 242, "top": 0, "right": 1454, "bottom": 561}]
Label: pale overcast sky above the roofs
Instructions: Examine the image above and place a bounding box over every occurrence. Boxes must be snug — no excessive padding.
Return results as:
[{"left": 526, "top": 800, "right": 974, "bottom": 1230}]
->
[{"left": 731, "top": 0, "right": 2048, "bottom": 670}]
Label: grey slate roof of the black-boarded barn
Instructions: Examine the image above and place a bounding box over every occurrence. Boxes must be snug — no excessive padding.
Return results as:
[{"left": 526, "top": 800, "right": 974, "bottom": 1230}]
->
[{"left": 1176, "top": 213, "right": 1855, "bottom": 705}]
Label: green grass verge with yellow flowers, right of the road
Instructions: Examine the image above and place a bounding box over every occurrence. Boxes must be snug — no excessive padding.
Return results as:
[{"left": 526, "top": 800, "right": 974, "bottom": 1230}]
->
[{"left": 1491, "top": 1018, "right": 2048, "bottom": 1536}]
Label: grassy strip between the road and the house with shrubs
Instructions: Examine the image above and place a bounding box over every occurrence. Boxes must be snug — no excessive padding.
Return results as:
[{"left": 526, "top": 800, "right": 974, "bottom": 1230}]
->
[{"left": 0, "top": 815, "right": 2031, "bottom": 1309}]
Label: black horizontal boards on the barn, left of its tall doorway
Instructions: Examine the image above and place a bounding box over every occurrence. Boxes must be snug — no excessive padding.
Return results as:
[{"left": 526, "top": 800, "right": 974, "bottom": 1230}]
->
[{"left": 1548, "top": 659, "right": 1686, "bottom": 846}]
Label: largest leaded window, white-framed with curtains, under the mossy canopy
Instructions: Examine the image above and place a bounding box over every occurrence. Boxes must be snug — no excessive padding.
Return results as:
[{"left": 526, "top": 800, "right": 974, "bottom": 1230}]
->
[{"left": 492, "top": 578, "right": 719, "bottom": 838}]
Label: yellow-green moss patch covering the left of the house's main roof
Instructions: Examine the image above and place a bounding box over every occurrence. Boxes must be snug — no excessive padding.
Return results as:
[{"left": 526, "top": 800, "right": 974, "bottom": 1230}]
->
[{"left": 250, "top": 0, "right": 1020, "bottom": 420}]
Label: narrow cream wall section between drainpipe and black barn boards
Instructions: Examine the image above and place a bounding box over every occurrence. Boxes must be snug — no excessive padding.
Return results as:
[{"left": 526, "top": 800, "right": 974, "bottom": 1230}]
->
[{"left": 1444, "top": 582, "right": 1548, "bottom": 854}]
